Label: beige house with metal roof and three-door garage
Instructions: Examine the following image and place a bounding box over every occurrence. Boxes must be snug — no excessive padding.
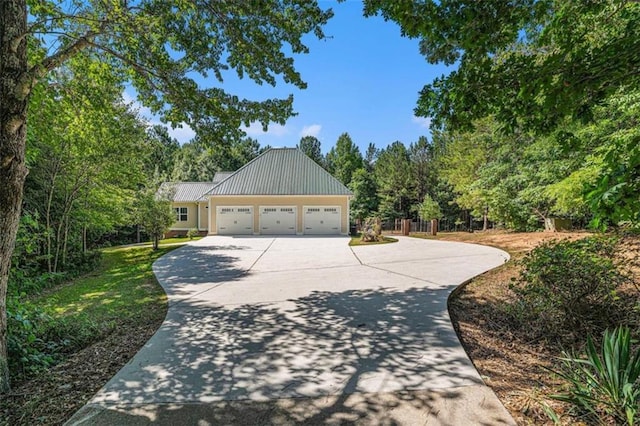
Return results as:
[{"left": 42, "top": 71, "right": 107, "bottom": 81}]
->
[{"left": 165, "top": 148, "right": 353, "bottom": 235}]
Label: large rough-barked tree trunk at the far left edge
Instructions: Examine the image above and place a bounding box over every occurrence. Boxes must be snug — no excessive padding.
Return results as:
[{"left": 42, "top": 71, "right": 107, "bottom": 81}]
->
[{"left": 0, "top": 0, "right": 30, "bottom": 393}]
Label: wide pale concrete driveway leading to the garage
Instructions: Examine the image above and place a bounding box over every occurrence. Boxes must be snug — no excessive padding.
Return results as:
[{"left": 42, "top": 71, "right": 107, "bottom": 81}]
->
[{"left": 69, "top": 236, "right": 514, "bottom": 425}]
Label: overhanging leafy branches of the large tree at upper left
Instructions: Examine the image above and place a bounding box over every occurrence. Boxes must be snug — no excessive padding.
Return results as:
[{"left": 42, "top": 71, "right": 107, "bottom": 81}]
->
[{"left": 29, "top": 0, "right": 333, "bottom": 136}]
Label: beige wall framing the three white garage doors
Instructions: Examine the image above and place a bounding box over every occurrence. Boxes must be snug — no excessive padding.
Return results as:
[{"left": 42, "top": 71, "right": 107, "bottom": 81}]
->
[{"left": 208, "top": 195, "right": 349, "bottom": 235}]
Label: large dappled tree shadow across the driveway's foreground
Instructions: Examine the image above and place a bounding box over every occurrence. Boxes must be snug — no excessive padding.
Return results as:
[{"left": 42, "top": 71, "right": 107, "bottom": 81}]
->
[{"left": 82, "top": 288, "right": 507, "bottom": 425}]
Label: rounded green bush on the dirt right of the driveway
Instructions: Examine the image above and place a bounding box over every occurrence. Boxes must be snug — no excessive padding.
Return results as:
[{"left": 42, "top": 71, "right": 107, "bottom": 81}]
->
[{"left": 512, "top": 236, "right": 629, "bottom": 343}]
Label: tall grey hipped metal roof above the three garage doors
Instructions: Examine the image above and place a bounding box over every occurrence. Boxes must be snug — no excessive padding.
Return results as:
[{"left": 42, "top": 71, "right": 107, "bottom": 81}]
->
[{"left": 208, "top": 148, "right": 353, "bottom": 195}]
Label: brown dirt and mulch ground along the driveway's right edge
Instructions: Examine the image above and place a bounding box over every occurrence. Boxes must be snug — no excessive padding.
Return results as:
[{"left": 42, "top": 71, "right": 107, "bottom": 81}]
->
[{"left": 437, "top": 232, "right": 640, "bottom": 425}]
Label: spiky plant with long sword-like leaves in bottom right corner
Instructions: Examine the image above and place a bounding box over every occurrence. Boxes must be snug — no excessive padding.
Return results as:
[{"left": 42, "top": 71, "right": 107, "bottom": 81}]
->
[{"left": 551, "top": 327, "right": 640, "bottom": 426}]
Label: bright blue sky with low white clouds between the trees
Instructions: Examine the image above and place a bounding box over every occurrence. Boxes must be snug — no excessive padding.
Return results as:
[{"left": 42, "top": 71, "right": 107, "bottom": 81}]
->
[{"left": 127, "top": 0, "right": 448, "bottom": 153}]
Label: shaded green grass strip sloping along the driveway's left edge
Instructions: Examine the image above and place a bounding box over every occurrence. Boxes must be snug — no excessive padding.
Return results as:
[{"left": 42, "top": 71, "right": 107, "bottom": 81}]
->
[{"left": 0, "top": 243, "right": 178, "bottom": 425}]
